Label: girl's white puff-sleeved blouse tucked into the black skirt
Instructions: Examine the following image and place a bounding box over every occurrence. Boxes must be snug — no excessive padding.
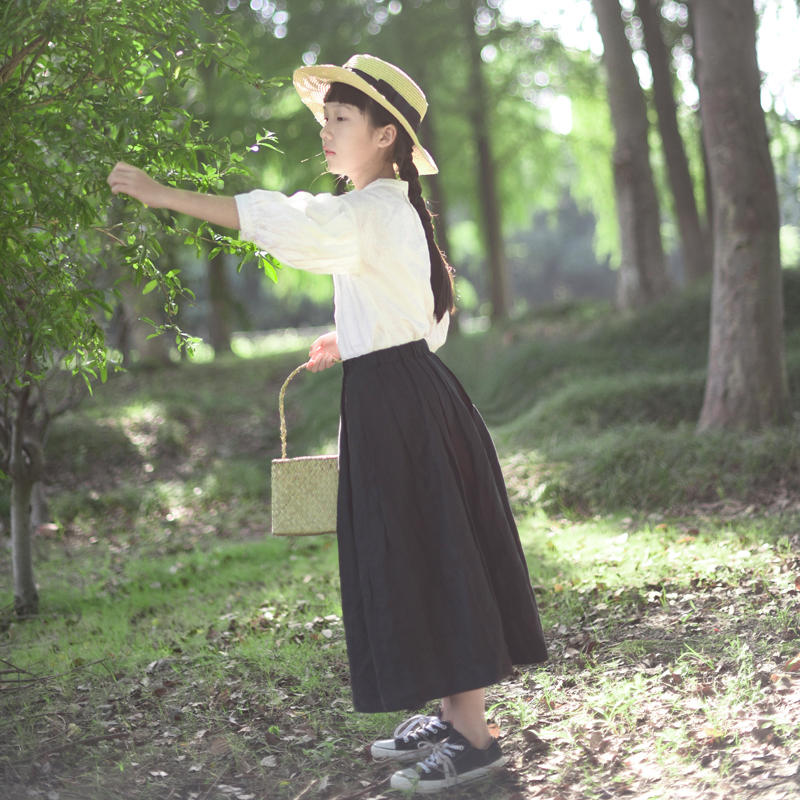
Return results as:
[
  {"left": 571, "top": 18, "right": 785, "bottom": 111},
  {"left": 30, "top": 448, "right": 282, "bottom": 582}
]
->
[{"left": 236, "top": 178, "right": 449, "bottom": 359}]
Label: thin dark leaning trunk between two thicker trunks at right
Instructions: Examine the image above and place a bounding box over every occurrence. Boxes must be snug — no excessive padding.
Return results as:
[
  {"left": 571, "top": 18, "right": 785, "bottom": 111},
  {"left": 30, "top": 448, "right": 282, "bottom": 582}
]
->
[{"left": 636, "top": 0, "right": 711, "bottom": 282}]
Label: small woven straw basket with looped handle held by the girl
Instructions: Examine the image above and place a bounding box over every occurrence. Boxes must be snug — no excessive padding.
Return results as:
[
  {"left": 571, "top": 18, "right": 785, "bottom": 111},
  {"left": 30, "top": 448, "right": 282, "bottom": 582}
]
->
[{"left": 272, "top": 364, "right": 339, "bottom": 536}]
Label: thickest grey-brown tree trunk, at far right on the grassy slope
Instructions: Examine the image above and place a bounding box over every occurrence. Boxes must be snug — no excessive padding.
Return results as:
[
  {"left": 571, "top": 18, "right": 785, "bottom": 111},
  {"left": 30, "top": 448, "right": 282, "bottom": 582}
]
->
[{"left": 693, "top": 0, "right": 791, "bottom": 430}]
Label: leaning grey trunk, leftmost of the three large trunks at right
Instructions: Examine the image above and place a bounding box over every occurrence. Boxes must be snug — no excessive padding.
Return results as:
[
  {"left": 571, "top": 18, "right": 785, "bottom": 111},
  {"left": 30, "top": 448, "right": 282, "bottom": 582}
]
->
[{"left": 592, "top": 0, "right": 670, "bottom": 309}]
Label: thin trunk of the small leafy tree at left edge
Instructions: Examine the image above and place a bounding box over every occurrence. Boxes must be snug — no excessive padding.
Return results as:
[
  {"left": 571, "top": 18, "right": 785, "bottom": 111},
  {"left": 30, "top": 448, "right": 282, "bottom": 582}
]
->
[{"left": 8, "top": 386, "right": 44, "bottom": 616}]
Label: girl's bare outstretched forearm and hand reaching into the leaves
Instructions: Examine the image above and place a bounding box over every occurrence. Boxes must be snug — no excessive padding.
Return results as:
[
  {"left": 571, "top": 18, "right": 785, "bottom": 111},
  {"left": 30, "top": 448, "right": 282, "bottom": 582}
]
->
[{"left": 108, "top": 161, "right": 241, "bottom": 231}]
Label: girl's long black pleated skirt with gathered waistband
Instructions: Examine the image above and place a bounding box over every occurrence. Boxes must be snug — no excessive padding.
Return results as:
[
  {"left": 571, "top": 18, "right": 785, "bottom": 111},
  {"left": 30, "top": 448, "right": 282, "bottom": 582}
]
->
[{"left": 337, "top": 341, "right": 547, "bottom": 712}]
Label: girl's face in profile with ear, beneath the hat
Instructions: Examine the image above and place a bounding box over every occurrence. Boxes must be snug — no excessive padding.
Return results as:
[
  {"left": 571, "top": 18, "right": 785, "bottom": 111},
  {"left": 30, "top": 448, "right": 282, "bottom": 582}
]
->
[{"left": 320, "top": 102, "right": 397, "bottom": 189}]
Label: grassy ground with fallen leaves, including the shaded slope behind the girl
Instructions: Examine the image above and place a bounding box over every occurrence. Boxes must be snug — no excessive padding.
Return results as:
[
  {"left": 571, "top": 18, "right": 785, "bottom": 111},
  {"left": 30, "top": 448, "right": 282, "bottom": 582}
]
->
[{"left": 0, "top": 284, "right": 800, "bottom": 800}]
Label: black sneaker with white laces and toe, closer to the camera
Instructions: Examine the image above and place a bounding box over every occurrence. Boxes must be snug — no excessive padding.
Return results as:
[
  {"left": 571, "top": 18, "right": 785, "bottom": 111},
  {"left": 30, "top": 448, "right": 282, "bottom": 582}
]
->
[{"left": 391, "top": 730, "right": 506, "bottom": 794}]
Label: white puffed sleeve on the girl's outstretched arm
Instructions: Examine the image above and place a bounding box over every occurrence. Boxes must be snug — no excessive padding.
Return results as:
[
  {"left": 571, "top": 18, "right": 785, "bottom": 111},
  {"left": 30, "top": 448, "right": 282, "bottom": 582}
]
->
[{"left": 236, "top": 189, "right": 359, "bottom": 275}]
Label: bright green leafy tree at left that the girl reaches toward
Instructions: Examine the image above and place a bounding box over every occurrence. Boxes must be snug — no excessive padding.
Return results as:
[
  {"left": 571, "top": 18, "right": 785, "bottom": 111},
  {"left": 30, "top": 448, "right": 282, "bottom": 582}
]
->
[{"left": 0, "top": 0, "right": 274, "bottom": 614}]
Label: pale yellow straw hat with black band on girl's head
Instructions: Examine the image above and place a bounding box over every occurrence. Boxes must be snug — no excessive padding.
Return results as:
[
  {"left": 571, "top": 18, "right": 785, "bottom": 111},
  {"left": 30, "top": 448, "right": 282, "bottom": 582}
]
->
[{"left": 294, "top": 55, "right": 439, "bottom": 175}]
